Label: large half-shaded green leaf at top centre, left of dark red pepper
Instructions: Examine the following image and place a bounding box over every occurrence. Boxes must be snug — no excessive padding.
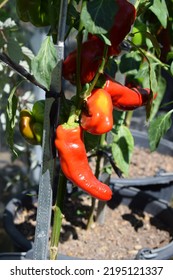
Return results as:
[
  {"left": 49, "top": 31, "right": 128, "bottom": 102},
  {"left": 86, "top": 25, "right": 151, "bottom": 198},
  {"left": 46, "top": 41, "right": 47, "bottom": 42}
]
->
[{"left": 81, "top": 0, "right": 118, "bottom": 34}]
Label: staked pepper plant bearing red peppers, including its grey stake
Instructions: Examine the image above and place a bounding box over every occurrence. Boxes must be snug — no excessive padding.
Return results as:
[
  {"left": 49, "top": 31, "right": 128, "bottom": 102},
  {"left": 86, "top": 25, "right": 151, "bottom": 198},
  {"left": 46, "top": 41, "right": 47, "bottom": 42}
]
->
[{"left": 0, "top": 0, "right": 173, "bottom": 259}]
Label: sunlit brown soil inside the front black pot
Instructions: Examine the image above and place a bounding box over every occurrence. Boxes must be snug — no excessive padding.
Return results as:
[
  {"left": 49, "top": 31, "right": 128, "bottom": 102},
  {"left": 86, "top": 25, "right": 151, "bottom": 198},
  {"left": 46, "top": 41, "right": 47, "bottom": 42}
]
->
[{"left": 56, "top": 197, "right": 172, "bottom": 259}]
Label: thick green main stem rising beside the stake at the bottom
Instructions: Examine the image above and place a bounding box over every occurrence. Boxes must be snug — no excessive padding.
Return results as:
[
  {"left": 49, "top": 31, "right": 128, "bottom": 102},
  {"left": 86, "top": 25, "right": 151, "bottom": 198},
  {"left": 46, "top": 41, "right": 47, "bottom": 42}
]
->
[{"left": 50, "top": 171, "right": 67, "bottom": 260}]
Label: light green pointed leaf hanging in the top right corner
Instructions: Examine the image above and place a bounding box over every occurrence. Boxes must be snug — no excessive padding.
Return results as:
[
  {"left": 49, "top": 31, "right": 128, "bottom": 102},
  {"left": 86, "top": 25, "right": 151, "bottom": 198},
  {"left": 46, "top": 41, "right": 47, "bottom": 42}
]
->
[{"left": 150, "top": 0, "right": 168, "bottom": 28}]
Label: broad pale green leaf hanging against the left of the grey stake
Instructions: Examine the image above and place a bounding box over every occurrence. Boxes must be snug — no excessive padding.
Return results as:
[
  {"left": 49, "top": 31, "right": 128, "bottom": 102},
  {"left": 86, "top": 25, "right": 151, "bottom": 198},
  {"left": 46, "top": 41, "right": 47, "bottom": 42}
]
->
[{"left": 31, "top": 36, "right": 57, "bottom": 90}]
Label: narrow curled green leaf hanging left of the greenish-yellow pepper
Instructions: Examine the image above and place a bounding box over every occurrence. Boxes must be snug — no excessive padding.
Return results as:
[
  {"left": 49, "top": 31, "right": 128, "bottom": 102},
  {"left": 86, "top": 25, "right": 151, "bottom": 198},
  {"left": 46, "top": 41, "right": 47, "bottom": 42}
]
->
[{"left": 6, "top": 85, "right": 18, "bottom": 158}]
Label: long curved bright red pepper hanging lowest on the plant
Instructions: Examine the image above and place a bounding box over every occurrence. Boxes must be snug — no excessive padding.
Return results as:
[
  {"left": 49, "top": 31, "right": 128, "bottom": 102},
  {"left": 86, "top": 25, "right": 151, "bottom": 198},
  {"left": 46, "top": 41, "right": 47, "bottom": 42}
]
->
[{"left": 55, "top": 124, "right": 112, "bottom": 201}]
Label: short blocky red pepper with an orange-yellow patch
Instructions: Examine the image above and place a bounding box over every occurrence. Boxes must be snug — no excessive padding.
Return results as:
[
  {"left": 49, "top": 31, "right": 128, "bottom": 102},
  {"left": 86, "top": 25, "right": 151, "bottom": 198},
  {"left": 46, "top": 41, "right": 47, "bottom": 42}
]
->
[{"left": 80, "top": 89, "right": 113, "bottom": 134}]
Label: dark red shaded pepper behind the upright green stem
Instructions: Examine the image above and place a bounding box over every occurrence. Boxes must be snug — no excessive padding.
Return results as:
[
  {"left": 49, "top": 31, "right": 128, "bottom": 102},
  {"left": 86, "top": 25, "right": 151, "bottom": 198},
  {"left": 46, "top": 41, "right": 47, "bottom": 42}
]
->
[{"left": 62, "top": 36, "right": 104, "bottom": 84}]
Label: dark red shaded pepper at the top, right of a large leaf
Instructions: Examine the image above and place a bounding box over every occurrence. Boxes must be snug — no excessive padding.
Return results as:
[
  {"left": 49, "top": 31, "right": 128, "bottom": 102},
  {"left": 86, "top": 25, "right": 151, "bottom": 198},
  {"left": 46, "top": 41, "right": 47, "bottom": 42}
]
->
[{"left": 109, "top": 0, "right": 136, "bottom": 55}]
